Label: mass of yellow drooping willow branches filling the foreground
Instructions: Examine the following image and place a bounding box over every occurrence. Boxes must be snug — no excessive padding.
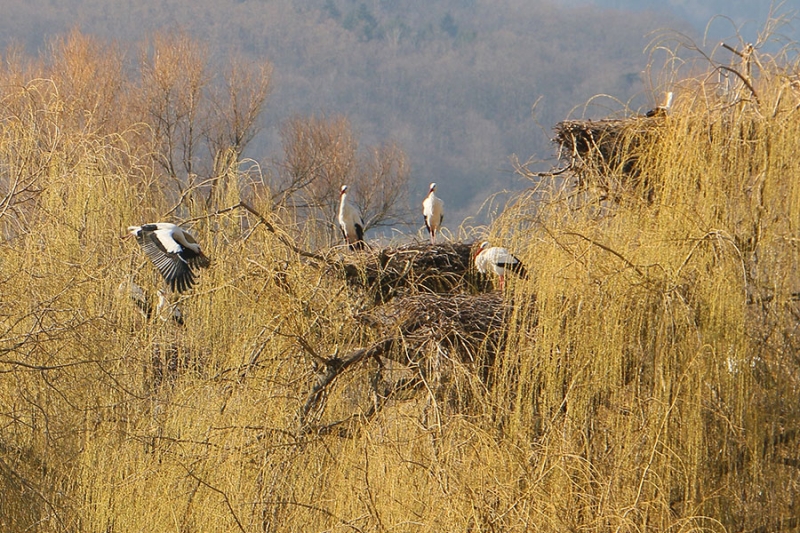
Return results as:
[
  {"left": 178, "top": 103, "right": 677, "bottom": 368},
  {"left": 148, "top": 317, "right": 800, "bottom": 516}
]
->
[{"left": 0, "top": 27, "right": 800, "bottom": 532}]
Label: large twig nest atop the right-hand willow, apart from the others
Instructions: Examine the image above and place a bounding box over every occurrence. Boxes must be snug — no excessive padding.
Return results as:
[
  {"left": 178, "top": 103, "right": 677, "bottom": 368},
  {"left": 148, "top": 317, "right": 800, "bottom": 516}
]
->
[{"left": 553, "top": 114, "right": 664, "bottom": 200}]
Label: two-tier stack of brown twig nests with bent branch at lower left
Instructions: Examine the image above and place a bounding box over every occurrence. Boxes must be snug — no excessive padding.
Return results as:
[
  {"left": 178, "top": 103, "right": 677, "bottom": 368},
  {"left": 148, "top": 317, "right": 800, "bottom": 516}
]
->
[{"left": 299, "top": 243, "right": 520, "bottom": 432}]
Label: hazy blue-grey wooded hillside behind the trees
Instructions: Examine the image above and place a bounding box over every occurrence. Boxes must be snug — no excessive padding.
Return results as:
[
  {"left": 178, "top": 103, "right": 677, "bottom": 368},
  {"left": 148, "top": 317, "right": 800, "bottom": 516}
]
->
[{"left": 0, "top": 0, "right": 797, "bottom": 228}]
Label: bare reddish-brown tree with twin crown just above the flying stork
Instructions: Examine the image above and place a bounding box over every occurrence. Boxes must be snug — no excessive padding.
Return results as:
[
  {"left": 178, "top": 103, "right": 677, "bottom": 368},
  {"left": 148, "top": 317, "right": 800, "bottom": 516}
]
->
[{"left": 136, "top": 32, "right": 272, "bottom": 212}]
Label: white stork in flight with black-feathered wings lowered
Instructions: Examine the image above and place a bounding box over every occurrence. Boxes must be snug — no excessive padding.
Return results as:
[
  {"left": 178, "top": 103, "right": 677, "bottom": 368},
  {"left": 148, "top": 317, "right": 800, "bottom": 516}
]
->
[{"left": 128, "top": 222, "right": 211, "bottom": 292}]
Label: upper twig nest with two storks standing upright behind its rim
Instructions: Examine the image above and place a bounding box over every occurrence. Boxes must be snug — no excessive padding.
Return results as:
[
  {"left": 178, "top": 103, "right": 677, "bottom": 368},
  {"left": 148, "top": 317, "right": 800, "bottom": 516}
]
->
[{"left": 336, "top": 243, "right": 489, "bottom": 302}]
